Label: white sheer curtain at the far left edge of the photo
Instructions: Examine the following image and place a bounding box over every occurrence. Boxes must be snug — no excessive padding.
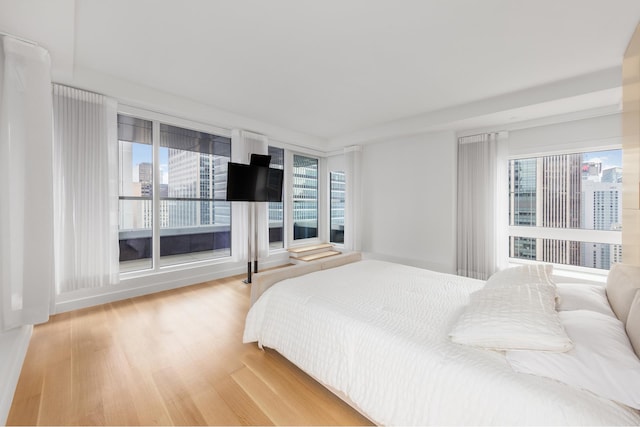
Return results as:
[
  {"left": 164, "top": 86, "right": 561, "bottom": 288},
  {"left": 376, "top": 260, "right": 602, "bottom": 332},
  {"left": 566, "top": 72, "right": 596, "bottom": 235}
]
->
[{"left": 0, "top": 36, "right": 54, "bottom": 330}]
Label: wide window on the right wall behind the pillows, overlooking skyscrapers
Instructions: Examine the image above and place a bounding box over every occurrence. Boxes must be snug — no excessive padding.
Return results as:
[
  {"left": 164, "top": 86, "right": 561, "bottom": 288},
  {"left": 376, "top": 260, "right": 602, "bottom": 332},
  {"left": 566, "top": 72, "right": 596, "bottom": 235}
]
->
[{"left": 509, "top": 150, "right": 622, "bottom": 270}]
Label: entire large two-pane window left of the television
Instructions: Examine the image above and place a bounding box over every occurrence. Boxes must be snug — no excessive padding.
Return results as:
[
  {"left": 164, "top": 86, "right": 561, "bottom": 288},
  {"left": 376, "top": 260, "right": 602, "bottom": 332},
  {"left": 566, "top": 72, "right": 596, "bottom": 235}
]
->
[{"left": 118, "top": 115, "right": 231, "bottom": 272}]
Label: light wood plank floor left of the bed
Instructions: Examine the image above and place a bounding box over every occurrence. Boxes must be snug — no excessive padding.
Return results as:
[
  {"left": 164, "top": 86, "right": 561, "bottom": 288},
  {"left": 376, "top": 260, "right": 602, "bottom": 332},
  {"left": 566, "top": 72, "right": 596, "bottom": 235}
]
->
[{"left": 7, "top": 276, "right": 371, "bottom": 425}]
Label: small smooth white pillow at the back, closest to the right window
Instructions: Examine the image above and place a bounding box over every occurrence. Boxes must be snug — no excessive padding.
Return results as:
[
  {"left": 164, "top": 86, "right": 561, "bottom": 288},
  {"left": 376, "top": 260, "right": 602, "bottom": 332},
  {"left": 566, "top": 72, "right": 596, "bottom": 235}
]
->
[{"left": 556, "top": 283, "right": 615, "bottom": 317}]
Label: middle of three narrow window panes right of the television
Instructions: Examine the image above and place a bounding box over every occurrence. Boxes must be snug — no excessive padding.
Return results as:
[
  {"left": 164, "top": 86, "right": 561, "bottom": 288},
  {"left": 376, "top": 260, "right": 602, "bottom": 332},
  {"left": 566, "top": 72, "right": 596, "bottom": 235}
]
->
[{"left": 293, "top": 154, "right": 318, "bottom": 240}]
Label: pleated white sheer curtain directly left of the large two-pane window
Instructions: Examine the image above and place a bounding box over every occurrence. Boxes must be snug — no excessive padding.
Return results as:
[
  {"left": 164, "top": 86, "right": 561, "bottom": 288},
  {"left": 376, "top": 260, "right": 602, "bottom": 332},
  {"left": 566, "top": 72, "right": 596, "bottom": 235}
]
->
[{"left": 53, "top": 85, "right": 119, "bottom": 294}]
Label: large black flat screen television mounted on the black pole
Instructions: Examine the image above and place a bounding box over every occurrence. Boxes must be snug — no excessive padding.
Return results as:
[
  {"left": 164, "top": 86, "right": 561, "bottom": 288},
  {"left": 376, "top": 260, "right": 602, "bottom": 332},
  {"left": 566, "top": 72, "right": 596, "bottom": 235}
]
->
[{"left": 226, "top": 162, "right": 284, "bottom": 202}]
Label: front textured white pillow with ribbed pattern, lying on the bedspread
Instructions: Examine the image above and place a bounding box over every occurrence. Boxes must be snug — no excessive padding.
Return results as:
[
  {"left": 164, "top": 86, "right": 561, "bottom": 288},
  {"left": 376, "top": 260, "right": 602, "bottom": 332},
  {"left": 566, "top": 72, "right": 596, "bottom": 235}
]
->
[{"left": 449, "top": 283, "right": 572, "bottom": 351}]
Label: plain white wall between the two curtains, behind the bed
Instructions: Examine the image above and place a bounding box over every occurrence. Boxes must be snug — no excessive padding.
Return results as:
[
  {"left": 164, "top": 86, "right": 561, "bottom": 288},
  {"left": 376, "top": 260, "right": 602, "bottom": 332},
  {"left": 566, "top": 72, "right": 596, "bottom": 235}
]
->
[{"left": 362, "top": 132, "right": 457, "bottom": 273}]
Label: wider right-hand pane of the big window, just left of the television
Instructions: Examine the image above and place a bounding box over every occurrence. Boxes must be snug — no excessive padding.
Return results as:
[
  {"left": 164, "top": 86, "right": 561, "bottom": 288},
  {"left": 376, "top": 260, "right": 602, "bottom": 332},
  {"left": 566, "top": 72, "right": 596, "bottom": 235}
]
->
[{"left": 159, "top": 123, "right": 231, "bottom": 266}]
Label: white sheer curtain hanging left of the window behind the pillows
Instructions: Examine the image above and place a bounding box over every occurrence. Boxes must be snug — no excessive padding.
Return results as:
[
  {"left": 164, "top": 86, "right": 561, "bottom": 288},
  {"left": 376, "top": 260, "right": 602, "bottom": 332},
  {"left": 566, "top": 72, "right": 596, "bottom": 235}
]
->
[{"left": 457, "top": 132, "right": 508, "bottom": 280}]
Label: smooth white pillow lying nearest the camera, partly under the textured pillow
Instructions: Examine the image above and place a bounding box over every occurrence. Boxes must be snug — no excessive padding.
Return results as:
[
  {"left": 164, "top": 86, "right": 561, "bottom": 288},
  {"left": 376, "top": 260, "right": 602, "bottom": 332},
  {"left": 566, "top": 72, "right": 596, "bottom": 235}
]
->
[{"left": 506, "top": 310, "right": 640, "bottom": 409}]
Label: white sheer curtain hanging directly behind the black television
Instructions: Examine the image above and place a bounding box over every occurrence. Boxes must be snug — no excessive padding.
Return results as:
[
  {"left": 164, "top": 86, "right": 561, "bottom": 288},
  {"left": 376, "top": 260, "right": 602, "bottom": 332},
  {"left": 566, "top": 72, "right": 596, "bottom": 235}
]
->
[{"left": 231, "top": 129, "right": 269, "bottom": 261}]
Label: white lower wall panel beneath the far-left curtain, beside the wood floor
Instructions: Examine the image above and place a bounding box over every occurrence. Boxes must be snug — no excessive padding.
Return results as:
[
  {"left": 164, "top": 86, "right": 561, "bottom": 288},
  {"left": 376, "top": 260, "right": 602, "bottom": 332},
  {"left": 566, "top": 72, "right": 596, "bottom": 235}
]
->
[{"left": 0, "top": 325, "right": 33, "bottom": 425}]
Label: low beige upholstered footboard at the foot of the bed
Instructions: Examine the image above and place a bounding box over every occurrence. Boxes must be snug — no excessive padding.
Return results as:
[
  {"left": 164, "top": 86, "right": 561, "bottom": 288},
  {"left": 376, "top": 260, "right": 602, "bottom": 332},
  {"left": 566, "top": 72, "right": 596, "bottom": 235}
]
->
[{"left": 251, "top": 252, "right": 362, "bottom": 305}]
